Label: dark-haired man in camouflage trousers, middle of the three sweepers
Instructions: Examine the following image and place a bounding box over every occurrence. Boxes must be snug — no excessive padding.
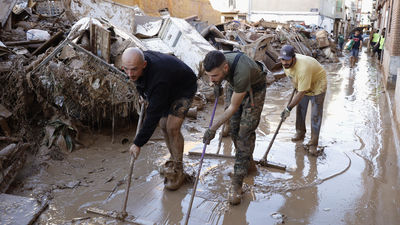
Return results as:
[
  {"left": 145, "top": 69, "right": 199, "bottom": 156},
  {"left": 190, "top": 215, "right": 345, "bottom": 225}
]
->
[{"left": 203, "top": 51, "right": 266, "bottom": 205}]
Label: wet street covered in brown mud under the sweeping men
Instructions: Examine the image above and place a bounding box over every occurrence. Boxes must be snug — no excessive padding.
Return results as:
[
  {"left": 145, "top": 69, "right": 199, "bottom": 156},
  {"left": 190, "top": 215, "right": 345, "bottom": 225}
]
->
[{"left": 9, "top": 53, "right": 400, "bottom": 225}]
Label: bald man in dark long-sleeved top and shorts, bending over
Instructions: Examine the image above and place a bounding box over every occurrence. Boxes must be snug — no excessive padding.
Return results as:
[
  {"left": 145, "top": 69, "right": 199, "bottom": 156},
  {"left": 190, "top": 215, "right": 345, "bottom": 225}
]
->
[{"left": 122, "top": 48, "right": 197, "bottom": 190}]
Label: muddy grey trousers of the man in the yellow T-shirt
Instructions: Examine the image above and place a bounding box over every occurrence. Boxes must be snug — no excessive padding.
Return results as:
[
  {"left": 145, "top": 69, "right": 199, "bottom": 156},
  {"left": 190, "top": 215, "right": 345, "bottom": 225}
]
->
[{"left": 296, "top": 92, "right": 325, "bottom": 145}]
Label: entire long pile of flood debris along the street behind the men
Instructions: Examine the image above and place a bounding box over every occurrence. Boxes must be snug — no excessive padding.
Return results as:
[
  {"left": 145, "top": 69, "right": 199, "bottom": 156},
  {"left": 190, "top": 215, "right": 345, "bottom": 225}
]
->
[{"left": 0, "top": 0, "right": 337, "bottom": 153}]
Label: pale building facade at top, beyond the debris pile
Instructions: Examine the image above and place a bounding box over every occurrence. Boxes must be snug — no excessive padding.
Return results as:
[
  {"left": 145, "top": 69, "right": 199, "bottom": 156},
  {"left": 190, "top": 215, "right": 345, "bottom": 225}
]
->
[{"left": 210, "top": 0, "right": 345, "bottom": 32}]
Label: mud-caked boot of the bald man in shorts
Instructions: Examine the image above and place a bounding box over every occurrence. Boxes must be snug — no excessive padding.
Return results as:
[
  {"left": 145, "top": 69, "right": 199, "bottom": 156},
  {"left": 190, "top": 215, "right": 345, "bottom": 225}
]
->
[{"left": 164, "top": 161, "right": 185, "bottom": 191}]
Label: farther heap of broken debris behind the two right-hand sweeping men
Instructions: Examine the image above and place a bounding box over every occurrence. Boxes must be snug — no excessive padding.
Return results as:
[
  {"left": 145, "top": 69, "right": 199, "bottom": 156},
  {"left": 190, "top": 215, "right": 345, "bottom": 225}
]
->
[{"left": 201, "top": 19, "right": 337, "bottom": 72}]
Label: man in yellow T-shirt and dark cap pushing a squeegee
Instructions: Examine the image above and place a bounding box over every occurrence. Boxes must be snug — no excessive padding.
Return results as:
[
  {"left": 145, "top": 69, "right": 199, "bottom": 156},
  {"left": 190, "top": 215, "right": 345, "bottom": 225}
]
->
[{"left": 279, "top": 45, "right": 327, "bottom": 154}]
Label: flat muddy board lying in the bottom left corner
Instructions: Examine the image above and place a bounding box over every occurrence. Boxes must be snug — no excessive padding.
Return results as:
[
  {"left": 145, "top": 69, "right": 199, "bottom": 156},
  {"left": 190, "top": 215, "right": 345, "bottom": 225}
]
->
[{"left": 0, "top": 194, "right": 48, "bottom": 225}]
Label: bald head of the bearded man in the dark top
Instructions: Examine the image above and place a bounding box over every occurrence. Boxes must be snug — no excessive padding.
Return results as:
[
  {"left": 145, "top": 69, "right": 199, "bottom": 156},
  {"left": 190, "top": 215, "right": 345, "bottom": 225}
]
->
[{"left": 122, "top": 47, "right": 147, "bottom": 81}]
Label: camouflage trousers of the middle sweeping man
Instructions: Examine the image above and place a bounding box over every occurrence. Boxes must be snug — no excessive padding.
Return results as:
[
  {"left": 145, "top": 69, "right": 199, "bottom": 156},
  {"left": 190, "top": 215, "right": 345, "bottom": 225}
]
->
[{"left": 225, "top": 82, "right": 266, "bottom": 185}]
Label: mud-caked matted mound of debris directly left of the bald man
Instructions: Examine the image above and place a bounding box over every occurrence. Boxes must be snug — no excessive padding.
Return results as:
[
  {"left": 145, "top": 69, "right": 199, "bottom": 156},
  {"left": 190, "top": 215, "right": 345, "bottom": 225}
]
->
[{"left": 28, "top": 45, "right": 138, "bottom": 121}]
